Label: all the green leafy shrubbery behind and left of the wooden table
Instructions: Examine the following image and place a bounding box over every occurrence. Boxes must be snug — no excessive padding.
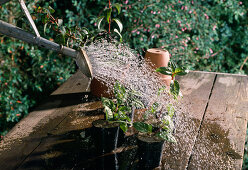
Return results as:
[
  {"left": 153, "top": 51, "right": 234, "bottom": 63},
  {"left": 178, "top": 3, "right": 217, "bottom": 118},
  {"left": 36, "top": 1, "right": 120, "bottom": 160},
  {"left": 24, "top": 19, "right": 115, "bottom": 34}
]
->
[{"left": 0, "top": 0, "right": 248, "bottom": 167}]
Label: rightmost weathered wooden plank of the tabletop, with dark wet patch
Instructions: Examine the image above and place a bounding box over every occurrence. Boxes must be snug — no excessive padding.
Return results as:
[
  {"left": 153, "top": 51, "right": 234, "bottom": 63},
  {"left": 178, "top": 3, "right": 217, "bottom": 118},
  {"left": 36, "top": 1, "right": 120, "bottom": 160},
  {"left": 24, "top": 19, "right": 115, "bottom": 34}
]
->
[{"left": 188, "top": 75, "right": 248, "bottom": 169}]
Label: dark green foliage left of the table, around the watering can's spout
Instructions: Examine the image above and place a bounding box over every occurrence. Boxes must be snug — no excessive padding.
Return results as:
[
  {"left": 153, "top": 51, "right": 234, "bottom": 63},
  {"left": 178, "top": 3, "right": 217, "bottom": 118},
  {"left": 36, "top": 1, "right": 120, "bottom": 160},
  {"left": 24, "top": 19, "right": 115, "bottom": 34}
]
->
[{"left": 0, "top": 1, "right": 75, "bottom": 137}]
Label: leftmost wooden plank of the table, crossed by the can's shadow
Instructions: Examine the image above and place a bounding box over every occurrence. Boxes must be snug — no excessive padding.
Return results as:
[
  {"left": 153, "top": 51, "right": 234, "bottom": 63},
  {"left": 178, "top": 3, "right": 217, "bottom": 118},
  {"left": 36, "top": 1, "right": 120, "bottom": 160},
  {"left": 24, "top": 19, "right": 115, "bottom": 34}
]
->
[{"left": 0, "top": 69, "right": 88, "bottom": 170}]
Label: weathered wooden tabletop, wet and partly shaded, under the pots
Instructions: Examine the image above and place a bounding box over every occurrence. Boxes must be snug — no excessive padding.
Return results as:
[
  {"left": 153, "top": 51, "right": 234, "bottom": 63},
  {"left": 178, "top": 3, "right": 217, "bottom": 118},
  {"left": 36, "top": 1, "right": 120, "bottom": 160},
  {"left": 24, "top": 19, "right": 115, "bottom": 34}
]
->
[{"left": 0, "top": 72, "right": 248, "bottom": 170}]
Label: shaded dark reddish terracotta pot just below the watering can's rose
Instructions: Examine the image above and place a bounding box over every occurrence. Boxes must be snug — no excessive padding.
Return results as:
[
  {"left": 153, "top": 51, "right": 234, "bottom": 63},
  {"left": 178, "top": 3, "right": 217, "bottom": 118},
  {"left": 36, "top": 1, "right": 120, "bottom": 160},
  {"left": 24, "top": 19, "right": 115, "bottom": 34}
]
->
[{"left": 90, "top": 78, "right": 114, "bottom": 98}]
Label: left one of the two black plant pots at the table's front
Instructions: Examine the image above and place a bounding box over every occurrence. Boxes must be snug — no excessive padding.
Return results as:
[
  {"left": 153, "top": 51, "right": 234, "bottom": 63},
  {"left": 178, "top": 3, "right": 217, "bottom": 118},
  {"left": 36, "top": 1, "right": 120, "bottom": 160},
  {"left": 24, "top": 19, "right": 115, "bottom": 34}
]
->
[{"left": 92, "top": 119, "right": 120, "bottom": 154}]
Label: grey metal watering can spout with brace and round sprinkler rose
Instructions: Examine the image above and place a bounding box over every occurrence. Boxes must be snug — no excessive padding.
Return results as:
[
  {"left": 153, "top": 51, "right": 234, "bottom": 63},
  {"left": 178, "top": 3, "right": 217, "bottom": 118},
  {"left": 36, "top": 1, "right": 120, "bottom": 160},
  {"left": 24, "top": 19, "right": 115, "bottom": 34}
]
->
[{"left": 0, "top": 0, "right": 92, "bottom": 78}]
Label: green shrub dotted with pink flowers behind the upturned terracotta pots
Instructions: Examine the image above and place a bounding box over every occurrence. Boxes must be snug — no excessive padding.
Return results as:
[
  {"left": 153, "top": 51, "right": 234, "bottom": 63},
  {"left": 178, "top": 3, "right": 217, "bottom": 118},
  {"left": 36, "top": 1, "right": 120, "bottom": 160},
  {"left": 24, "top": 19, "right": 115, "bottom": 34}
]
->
[{"left": 66, "top": 0, "right": 248, "bottom": 74}]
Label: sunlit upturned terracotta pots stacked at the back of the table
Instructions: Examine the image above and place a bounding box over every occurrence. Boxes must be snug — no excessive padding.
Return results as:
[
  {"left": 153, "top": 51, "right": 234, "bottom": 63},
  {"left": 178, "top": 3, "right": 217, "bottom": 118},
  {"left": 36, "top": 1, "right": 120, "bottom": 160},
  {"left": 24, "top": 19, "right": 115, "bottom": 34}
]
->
[{"left": 145, "top": 48, "right": 171, "bottom": 86}]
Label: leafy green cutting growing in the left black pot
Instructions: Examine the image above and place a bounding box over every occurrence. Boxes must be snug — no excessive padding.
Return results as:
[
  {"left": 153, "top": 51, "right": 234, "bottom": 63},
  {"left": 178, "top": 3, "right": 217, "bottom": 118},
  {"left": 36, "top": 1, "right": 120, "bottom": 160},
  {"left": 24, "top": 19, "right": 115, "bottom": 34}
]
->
[{"left": 101, "top": 82, "right": 144, "bottom": 132}]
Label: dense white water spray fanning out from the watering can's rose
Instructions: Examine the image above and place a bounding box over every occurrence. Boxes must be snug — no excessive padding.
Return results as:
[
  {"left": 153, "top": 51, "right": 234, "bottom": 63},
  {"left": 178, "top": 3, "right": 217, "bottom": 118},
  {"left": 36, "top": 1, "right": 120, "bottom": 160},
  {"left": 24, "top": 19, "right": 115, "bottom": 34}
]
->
[{"left": 86, "top": 40, "right": 174, "bottom": 110}]
